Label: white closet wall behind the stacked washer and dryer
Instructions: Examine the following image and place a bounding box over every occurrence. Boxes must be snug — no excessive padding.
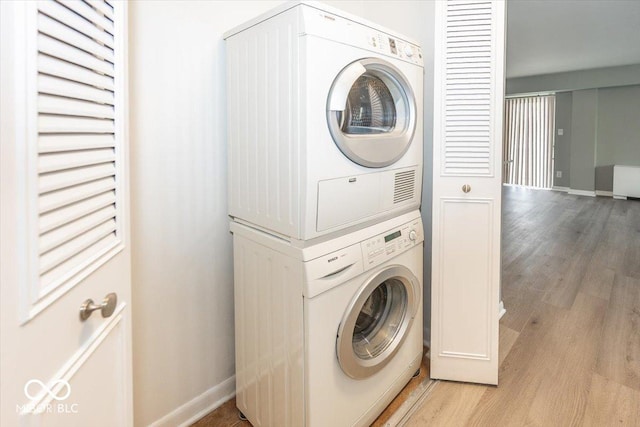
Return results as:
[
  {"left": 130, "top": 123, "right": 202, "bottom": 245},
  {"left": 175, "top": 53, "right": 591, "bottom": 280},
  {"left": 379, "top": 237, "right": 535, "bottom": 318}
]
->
[{"left": 130, "top": 1, "right": 434, "bottom": 426}]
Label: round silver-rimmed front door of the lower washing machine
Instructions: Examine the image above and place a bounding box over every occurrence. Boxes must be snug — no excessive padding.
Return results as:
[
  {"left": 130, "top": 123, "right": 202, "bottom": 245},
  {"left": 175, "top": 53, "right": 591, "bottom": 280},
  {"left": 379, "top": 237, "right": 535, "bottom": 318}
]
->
[{"left": 336, "top": 265, "right": 420, "bottom": 379}]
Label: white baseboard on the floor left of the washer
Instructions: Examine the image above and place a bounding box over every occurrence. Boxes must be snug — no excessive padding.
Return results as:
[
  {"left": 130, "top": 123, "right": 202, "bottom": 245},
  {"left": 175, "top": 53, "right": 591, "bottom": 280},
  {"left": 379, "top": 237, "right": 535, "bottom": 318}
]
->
[{"left": 150, "top": 375, "right": 236, "bottom": 427}]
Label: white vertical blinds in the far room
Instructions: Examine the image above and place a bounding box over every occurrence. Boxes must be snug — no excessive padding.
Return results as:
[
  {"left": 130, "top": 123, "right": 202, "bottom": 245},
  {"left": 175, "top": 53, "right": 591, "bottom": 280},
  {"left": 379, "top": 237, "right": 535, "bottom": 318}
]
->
[{"left": 502, "top": 95, "right": 555, "bottom": 188}]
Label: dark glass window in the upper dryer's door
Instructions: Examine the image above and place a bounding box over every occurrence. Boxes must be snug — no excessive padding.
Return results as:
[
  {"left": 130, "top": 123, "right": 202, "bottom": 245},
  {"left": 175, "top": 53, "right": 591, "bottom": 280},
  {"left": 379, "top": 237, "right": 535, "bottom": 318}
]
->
[{"left": 338, "top": 73, "right": 396, "bottom": 135}]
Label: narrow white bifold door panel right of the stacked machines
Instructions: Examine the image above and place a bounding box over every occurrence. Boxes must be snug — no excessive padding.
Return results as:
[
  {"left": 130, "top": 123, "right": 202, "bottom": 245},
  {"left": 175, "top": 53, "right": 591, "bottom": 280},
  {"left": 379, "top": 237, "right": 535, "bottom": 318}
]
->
[{"left": 431, "top": 0, "right": 505, "bottom": 384}]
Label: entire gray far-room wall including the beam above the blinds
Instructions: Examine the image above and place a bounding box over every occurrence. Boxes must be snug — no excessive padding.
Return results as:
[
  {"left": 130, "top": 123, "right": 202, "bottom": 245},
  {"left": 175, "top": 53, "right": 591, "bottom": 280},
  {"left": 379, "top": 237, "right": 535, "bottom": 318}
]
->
[{"left": 507, "top": 64, "right": 640, "bottom": 191}]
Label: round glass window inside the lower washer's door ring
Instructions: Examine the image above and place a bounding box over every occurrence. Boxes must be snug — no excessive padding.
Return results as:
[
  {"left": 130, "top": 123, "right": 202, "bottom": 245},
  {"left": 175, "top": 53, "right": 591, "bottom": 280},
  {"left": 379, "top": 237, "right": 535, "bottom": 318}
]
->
[{"left": 352, "top": 278, "right": 407, "bottom": 359}]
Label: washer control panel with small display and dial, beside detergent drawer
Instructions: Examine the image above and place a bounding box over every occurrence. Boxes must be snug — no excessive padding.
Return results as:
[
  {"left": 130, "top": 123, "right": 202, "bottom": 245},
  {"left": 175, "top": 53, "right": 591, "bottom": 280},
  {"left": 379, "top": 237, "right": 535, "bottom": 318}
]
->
[{"left": 361, "top": 219, "right": 424, "bottom": 266}]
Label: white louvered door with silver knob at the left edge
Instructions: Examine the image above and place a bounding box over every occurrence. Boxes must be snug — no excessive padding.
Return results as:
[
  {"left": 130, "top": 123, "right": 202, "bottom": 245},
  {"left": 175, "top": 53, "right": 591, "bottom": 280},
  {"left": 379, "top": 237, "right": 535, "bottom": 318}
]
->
[{"left": 0, "top": 0, "right": 133, "bottom": 426}]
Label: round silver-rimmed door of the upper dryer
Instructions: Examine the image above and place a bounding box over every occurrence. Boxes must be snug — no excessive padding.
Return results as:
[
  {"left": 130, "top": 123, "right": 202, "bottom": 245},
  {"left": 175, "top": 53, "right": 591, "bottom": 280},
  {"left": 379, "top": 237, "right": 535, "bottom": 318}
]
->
[{"left": 327, "top": 58, "right": 416, "bottom": 168}]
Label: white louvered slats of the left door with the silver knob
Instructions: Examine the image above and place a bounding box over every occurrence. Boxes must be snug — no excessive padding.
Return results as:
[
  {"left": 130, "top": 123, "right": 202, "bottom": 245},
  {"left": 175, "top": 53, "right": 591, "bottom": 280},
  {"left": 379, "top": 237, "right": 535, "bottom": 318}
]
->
[{"left": 37, "top": 1, "right": 119, "bottom": 293}]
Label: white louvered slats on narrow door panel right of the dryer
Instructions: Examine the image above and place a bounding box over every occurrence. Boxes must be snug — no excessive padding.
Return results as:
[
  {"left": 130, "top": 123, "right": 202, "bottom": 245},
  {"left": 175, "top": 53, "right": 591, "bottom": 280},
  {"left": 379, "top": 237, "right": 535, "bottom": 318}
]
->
[{"left": 442, "top": 0, "right": 493, "bottom": 175}]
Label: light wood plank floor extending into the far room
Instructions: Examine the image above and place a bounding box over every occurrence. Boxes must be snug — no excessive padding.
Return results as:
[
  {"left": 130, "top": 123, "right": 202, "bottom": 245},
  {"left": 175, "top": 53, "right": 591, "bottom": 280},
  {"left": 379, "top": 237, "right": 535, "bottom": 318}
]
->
[{"left": 408, "top": 187, "right": 640, "bottom": 427}]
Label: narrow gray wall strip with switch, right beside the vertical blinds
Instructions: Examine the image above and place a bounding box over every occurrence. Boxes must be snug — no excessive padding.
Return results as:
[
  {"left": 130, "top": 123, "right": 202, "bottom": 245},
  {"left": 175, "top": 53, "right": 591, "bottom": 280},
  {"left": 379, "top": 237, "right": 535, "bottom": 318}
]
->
[{"left": 553, "top": 92, "right": 573, "bottom": 187}]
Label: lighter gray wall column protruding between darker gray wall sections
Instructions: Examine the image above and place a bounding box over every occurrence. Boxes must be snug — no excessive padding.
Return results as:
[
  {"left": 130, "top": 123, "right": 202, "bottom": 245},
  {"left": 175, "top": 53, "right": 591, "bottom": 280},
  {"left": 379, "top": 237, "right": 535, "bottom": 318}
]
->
[{"left": 569, "top": 89, "right": 598, "bottom": 191}]
